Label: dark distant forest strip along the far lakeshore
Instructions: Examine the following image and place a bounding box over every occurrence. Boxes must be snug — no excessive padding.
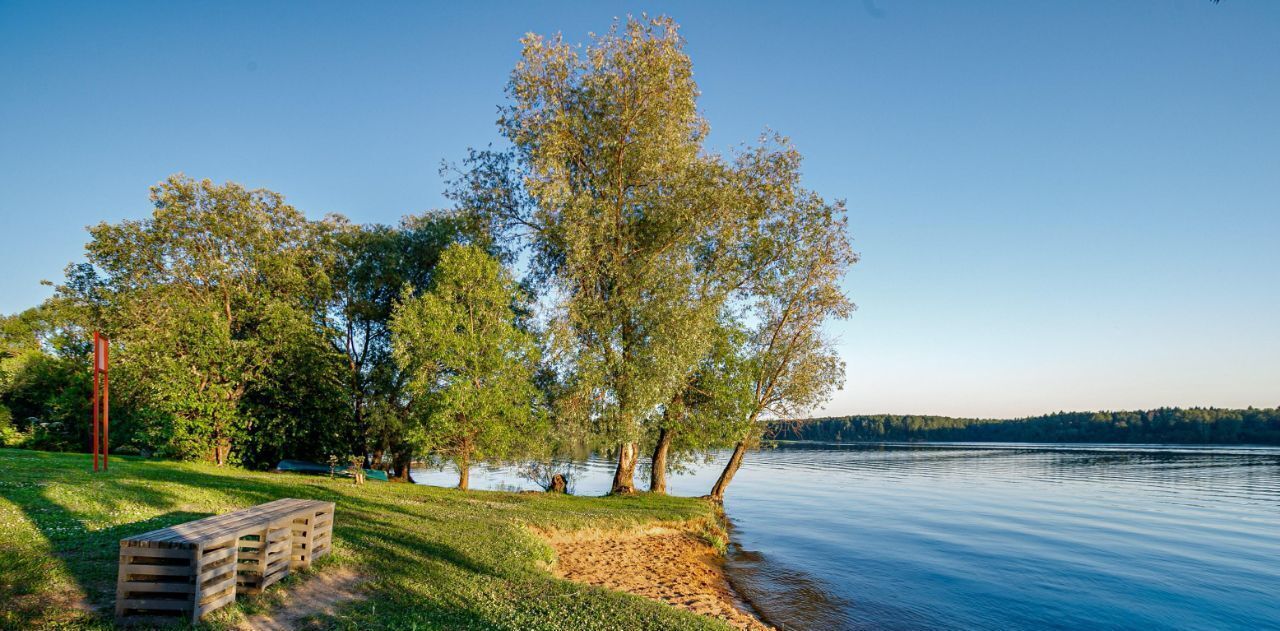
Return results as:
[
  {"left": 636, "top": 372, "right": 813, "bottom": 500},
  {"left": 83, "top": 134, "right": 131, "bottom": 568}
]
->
[{"left": 772, "top": 407, "right": 1280, "bottom": 444}]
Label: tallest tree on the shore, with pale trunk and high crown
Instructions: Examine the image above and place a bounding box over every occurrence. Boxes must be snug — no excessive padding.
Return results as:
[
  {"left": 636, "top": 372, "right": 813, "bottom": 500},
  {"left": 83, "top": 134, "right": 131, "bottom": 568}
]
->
[{"left": 453, "top": 18, "right": 736, "bottom": 493}]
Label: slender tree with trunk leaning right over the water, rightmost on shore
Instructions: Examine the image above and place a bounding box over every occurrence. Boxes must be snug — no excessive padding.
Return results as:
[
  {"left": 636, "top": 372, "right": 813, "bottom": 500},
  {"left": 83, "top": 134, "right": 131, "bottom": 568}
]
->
[{"left": 709, "top": 148, "right": 858, "bottom": 502}]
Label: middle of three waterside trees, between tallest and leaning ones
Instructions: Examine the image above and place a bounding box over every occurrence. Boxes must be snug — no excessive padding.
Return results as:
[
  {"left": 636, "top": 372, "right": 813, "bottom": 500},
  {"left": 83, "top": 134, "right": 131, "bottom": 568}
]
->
[{"left": 648, "top": 134, "right": 852, "bottom": 493}]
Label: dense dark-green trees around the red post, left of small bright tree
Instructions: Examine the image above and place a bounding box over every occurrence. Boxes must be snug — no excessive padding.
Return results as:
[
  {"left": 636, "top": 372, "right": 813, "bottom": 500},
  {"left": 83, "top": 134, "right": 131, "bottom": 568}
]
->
[{"left": 13, "top": 175, "right": 476, "bottom": 474}]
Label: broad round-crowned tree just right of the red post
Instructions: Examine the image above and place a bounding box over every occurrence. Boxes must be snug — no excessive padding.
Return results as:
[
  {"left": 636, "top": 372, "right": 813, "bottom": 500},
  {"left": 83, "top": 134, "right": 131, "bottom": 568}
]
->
[{"left": 60, "top": 175, "right": 328, "bottom": 465}]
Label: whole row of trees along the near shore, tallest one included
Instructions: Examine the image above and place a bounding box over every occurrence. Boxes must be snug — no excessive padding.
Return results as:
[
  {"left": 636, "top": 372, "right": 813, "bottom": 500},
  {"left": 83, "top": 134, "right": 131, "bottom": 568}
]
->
[{"left": 0, "top": 18, "right": 858, "bottom": 499}]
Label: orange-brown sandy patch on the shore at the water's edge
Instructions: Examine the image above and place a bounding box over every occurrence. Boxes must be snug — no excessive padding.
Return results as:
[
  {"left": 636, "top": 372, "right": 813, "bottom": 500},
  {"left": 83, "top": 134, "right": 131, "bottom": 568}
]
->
[{"left": 539, "top": 526, "right": 772, "bottom": 631}]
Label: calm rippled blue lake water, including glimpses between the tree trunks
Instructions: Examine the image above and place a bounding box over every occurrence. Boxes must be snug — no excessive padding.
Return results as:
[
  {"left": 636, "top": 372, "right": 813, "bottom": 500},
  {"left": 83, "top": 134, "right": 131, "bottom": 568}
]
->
[{"left": 413, "top": 443, "right": 1280, "bottom": 630}]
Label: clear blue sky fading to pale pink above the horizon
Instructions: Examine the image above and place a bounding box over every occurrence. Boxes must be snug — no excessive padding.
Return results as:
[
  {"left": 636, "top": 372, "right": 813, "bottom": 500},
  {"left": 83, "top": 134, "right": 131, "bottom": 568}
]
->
[{"left": 0, "top": 0, "right": 1280, "bottom": 417}]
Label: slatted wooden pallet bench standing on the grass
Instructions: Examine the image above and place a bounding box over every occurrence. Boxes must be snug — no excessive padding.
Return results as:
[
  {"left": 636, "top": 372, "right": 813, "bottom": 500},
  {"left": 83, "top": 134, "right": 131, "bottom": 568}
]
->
[{"left": 115, "top": 499, "right": 334, "bottom": 622}]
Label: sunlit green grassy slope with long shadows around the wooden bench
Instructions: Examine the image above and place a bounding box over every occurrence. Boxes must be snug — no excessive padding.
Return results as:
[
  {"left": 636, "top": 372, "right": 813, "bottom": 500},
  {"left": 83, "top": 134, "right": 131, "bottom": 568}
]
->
[{"left": 0, "top": 449, "right": 724, "bottom": 630}]
